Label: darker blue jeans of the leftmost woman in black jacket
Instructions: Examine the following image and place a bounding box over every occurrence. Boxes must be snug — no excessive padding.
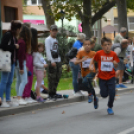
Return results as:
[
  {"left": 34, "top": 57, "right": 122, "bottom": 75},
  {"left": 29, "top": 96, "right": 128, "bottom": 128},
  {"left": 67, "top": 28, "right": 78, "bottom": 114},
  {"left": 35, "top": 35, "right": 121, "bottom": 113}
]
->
[{"left": 0, "top": 64, "right": 15, "bottom": 101}]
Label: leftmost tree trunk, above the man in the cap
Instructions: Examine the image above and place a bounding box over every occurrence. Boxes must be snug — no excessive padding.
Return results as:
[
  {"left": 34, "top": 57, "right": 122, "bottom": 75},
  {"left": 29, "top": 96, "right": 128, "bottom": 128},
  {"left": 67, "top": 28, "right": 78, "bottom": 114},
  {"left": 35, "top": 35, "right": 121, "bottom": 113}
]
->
[{"left": 42, "top": 0, "right": 55, "bottom": 28}]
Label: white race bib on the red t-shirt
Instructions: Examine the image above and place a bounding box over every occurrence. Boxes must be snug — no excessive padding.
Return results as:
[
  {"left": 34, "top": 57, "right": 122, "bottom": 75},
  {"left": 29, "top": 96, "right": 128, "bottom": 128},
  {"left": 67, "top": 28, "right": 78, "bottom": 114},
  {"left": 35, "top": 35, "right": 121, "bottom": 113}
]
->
[{"left": 101, "top": 62, "right": 113, "bottom": 71}]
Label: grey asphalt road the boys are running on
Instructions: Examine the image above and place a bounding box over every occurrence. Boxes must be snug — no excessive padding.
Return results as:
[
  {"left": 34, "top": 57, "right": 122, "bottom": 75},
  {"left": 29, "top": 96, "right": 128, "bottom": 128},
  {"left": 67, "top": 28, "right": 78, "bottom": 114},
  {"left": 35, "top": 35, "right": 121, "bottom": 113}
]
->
[{"left": 0, "top": 92, "right": 134, "bottom": 134}]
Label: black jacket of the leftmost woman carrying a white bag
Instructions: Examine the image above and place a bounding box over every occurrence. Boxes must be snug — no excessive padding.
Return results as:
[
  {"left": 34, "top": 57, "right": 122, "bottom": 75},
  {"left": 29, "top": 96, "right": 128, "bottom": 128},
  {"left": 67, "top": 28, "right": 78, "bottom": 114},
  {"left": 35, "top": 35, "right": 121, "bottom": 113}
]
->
[{"left": 0, "top": 32, "right": 17, "bottom": 64}]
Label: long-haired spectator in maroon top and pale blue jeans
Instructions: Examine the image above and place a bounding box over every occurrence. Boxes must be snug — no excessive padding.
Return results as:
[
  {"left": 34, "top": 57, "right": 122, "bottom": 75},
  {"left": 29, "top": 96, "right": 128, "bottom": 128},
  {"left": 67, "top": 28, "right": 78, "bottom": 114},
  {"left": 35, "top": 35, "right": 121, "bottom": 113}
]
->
[{"left": 16, "top": 25, "right": 31, "bottom": 105}]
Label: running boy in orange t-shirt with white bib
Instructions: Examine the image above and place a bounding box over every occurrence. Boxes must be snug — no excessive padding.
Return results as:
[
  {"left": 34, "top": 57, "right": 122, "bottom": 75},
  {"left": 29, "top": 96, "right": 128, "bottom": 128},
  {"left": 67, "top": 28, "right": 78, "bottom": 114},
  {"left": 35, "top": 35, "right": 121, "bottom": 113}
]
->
[{"left": 75, "top": 39, "right": 98, "bottom": 109}]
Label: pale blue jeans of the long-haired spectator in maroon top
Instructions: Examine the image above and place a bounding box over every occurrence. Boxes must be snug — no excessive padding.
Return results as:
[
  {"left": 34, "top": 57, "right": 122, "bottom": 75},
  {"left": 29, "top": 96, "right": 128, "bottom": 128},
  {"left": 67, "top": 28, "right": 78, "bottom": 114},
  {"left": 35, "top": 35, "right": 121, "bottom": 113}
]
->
[{"left": 16, "top": 61, "right": 28, "bottom": 97}]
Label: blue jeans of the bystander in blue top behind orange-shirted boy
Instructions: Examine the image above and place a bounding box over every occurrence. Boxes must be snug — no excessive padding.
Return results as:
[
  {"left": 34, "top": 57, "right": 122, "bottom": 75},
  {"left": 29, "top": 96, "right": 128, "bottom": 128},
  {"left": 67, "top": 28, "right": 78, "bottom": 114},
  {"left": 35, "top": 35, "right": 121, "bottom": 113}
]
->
[{"left": 69, "top": 62, "right": 80, "bottom": 92}]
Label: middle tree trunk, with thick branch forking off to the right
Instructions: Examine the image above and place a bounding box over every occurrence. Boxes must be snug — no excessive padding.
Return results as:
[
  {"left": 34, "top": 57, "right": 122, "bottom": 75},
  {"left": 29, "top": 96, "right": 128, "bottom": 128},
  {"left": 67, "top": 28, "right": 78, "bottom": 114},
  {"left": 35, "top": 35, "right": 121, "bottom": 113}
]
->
[{"left": 82, "top": 0, "right": 92, "bottom": 38}]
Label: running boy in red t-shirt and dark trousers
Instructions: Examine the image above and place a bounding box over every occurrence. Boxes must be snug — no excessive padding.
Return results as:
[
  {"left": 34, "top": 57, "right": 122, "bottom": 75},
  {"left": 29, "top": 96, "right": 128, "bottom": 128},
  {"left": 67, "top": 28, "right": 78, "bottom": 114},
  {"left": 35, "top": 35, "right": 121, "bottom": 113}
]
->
[{"left": 89, "top": 37, "right": 119, "bottom": 115}]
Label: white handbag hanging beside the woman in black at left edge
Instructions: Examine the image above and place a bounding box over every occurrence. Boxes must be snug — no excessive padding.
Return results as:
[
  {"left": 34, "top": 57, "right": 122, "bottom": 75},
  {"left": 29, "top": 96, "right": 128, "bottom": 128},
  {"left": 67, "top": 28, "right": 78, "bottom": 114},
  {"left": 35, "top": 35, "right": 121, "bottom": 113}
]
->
[{"left": 0, "top": 49, "right": 11, "bottom": 72}]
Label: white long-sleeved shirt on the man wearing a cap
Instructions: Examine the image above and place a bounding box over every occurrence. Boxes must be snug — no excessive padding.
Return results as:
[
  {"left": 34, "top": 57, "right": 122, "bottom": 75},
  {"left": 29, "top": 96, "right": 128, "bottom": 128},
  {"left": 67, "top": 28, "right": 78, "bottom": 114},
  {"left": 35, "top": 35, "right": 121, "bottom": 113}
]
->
[{"left": 45, "top": 36, "right": 61, "bottom": 63}]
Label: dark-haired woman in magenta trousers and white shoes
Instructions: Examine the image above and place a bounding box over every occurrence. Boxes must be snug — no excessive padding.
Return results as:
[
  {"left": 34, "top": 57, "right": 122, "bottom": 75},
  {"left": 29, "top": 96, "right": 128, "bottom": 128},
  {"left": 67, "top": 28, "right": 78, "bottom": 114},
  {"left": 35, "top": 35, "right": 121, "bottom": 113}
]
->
[{"left": 23, "top": 24, "right": 38, "bottom": 103}]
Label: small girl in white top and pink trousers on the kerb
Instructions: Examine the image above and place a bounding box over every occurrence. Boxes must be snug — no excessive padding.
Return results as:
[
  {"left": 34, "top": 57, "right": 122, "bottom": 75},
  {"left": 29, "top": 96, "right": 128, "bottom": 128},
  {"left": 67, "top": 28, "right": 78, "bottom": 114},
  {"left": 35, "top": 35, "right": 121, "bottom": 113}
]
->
[{"left": 33, "top": 43, "right": 47, "bottom": 102}]
